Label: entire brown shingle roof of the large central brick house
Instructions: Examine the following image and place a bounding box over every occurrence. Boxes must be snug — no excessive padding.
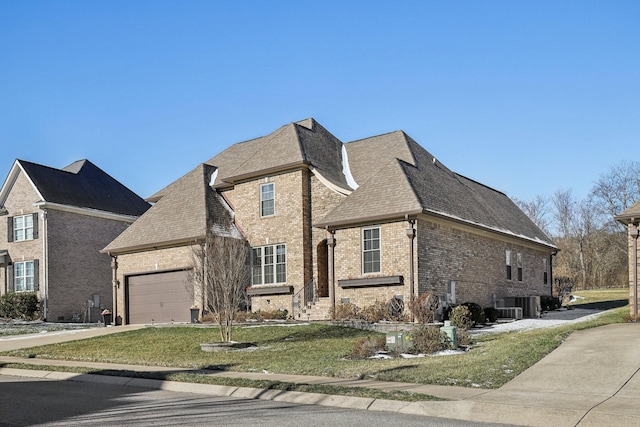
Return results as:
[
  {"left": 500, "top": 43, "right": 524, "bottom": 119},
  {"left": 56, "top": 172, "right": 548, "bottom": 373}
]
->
[{"left": 105, "top": 119, "right": 555, "bottom": 251}]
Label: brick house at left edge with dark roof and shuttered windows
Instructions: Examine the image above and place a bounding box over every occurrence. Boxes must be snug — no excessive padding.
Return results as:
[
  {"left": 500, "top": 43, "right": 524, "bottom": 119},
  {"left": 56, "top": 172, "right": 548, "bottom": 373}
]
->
[{"left": 0, "top": 160, "right": 150, "bottom": 321}]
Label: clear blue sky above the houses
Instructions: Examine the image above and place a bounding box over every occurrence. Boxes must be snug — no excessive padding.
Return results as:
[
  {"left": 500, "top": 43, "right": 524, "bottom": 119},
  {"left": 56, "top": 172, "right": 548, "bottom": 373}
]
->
[{"left": 0, "top": 0, "right": 640, "bottom": 200}]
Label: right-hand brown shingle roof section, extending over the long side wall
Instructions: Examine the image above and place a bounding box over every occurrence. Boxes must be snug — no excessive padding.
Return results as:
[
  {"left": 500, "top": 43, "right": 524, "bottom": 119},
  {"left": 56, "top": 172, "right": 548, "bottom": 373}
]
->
[{"left": 314, "top": 131, "right": 554, "bottom": 246}]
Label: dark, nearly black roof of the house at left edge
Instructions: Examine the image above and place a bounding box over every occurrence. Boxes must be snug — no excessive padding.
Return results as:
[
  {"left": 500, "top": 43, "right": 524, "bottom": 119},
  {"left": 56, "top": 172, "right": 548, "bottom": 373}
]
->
[{"left": 16, "top": 160, "right": 149, "bottom": 216}]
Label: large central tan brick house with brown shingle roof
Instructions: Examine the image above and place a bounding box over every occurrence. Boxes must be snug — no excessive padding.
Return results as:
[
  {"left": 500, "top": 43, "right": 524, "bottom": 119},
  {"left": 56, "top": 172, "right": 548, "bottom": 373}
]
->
[{"left": 104, "top": 119, "right": 557, "bottom": 323}]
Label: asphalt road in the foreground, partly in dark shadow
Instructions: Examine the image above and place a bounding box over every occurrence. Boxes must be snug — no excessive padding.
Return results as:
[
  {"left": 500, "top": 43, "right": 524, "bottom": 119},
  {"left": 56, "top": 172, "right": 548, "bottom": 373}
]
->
[{"left": 0, "top": 376, "right": 510, "bottom": 427}]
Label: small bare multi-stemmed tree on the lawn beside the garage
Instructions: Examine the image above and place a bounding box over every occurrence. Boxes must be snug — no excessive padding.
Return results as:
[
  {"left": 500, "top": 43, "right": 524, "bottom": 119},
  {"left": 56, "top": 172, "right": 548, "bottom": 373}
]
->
[{"left": 190, "top": 230, "right": 251, "bottom": 342}]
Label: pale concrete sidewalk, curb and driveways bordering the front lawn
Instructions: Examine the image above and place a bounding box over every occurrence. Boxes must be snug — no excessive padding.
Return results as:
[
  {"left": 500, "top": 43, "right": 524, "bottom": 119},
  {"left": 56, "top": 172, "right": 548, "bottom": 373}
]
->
[{"left": 0, "top": 324, "right": 640, "bottom": 426}]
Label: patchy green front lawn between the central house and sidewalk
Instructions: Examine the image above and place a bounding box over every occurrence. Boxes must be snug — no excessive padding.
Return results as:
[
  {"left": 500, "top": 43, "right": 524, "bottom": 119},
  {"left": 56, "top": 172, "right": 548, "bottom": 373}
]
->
[{"left": 4, "top": 307, "right": 628, "bottom": 388}]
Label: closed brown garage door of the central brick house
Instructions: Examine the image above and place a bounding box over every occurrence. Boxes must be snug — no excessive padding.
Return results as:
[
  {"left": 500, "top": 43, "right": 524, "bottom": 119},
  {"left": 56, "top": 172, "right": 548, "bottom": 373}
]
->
[{"left": 126, "top": 270, "right": 193, "bottom": 324}]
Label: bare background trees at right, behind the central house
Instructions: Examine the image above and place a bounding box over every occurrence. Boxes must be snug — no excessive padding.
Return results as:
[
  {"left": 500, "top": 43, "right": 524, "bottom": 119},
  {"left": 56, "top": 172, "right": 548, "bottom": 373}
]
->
[{"left": 515, "top": 161, "right": 640, "bottom": 289}]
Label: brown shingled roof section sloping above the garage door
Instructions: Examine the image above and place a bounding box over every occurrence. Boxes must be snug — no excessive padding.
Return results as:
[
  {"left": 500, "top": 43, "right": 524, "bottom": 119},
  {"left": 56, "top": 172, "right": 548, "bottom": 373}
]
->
[{"left": 102, "top": 164, "right": 234, "bottom": 253}]
